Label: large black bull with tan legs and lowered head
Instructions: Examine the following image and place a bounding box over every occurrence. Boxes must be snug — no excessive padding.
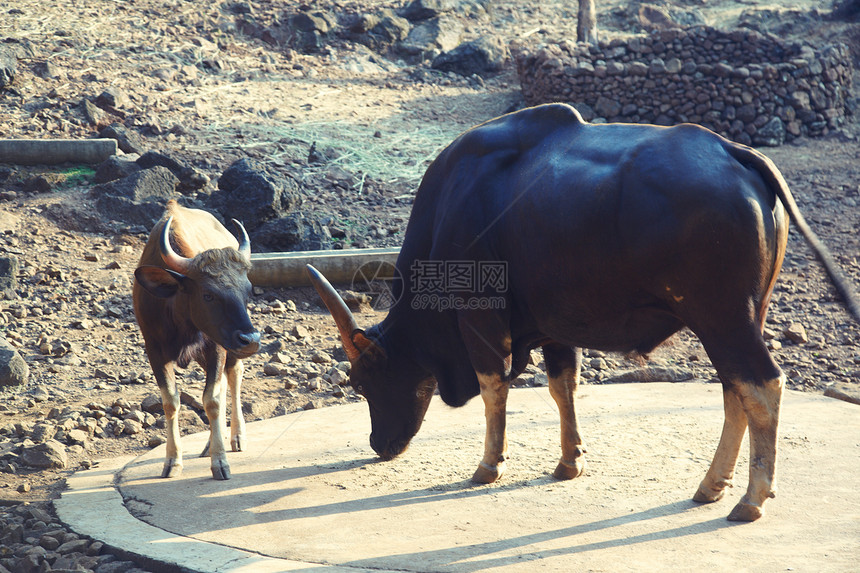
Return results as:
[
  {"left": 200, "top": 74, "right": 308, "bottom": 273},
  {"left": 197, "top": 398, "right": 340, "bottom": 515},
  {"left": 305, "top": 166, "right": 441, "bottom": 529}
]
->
[{"left": 308, "top": 100, "right": 860, "bottom": 521}]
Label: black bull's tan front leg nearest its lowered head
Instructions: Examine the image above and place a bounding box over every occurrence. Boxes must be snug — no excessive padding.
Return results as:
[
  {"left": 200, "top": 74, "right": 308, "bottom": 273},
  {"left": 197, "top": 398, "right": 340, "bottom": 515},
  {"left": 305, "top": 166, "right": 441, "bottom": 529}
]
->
[{"left": 472, "top": 373, "right": 508, "bottom": 483}]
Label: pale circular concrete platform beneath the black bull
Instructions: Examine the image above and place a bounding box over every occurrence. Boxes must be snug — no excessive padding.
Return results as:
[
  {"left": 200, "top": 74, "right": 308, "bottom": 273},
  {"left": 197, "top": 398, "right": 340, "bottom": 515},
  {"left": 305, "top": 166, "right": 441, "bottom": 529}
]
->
[{"left": 56, "top": 383, "right": 860, "bottom": 573}]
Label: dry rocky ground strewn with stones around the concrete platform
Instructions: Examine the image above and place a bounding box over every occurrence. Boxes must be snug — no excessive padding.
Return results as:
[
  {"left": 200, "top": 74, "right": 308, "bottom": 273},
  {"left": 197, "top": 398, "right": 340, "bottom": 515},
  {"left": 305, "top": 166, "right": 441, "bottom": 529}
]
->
[{"left": 0, "top": 0, "right": 860, "bottom": 573}]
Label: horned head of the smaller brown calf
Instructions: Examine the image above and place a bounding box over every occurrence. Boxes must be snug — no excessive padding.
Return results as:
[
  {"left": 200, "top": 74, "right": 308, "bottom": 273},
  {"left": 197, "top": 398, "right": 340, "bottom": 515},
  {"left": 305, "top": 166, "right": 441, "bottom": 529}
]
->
[{"left": 134, "top": 217, "right": 260, "bottom": 358}]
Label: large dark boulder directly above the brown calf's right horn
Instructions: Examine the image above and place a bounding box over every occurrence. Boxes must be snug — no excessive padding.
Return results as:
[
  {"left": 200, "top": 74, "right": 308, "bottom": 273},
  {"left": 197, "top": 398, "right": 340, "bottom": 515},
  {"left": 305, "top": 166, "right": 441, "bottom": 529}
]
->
[{"left": 209, "top": 158, "right": 302, "bottom": 231}]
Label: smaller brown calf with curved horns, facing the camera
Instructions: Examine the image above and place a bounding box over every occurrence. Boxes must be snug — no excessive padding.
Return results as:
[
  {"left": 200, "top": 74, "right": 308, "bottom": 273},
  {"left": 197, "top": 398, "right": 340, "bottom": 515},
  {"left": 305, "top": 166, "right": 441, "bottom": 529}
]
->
[{"left": 134, "top": 201, "right": 260, "bottom": 479}]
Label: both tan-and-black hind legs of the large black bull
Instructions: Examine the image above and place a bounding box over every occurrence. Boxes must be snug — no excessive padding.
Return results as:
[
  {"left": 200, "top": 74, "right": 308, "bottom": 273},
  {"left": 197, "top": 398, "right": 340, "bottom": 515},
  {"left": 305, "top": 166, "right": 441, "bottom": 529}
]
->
[{"left": 693, "top": 328, "right": 785, "bottom": 521}]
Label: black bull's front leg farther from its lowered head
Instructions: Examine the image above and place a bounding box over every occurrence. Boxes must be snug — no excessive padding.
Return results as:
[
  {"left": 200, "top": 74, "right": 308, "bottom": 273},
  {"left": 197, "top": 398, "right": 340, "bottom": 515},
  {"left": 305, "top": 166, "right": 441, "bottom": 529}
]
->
[{"left": 543, "top": 343, "right": 586, "bottom": 479}]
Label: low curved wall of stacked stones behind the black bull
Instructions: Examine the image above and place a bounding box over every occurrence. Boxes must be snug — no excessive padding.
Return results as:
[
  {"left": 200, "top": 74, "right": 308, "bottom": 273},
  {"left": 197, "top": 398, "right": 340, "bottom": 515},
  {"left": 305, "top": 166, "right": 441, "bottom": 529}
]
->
[{"left": 513, "top": 26, "right": 852, "bottom": 145}]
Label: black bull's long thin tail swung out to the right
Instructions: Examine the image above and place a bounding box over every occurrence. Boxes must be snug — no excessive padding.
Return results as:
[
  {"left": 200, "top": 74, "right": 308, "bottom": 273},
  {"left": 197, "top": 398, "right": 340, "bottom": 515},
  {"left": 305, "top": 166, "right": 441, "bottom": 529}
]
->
[{"left": 726, "top": 142, "right": 860, "bottom": 323}]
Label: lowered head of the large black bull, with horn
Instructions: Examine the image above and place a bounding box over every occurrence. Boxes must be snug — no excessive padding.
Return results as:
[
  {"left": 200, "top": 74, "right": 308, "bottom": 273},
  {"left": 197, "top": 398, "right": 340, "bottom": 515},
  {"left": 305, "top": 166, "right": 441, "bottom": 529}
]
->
[{"left": 307, "top": 265, "right": 436, "bottom": 460}]
